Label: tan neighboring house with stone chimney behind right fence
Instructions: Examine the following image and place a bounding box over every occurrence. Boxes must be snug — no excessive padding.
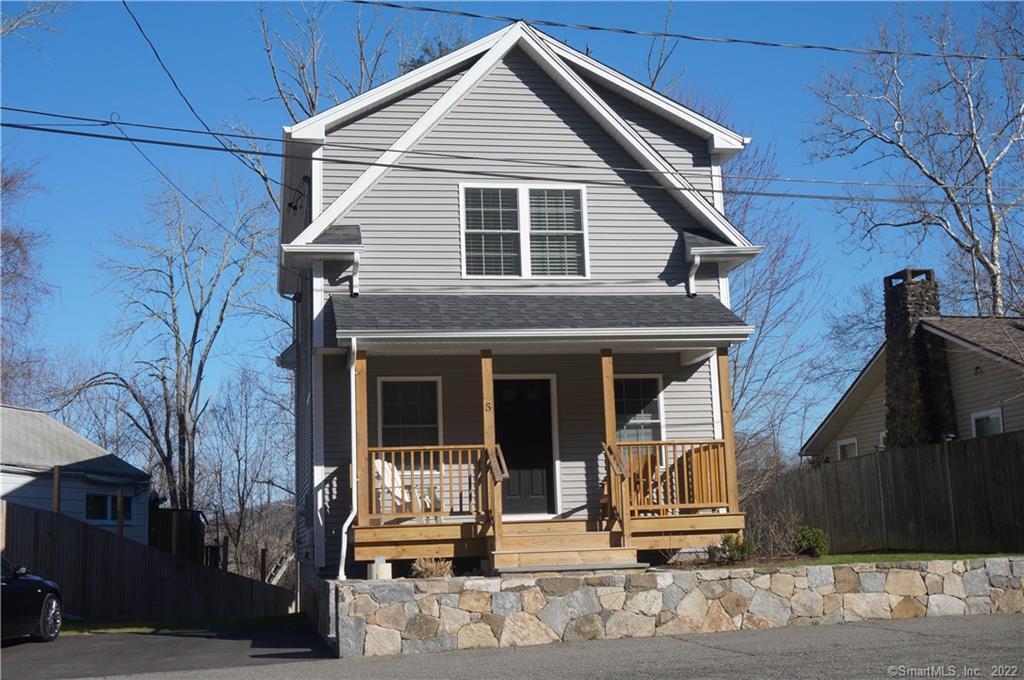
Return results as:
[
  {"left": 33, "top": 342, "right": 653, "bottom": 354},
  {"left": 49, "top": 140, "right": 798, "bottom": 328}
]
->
[{"left": 801, "top": 269, "right": 1024, "bottom": 460}]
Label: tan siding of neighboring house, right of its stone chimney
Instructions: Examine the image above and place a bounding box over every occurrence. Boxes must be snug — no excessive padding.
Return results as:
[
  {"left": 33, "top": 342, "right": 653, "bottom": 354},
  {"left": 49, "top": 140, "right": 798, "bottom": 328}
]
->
[{"left": 946, "top": 341, "right": 1024, "bottom": 439}]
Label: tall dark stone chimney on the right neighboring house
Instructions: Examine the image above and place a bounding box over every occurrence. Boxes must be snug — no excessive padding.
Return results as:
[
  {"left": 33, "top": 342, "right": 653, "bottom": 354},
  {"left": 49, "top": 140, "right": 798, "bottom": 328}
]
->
[{"left": 884, "top": 269, "right": 956, "bottom": 448}]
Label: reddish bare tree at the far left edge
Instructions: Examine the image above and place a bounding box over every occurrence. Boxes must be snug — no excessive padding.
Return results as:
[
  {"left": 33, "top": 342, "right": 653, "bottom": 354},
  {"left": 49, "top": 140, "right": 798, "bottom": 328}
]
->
[{"left": 0, "top": 154, "right": 53, "bottom": 406}]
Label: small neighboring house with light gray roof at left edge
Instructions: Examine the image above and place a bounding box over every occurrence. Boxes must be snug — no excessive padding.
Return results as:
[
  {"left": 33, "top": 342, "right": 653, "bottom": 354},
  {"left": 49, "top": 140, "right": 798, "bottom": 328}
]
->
[{"left": 0, "top": 406, "right": 150, "bottom": 543}]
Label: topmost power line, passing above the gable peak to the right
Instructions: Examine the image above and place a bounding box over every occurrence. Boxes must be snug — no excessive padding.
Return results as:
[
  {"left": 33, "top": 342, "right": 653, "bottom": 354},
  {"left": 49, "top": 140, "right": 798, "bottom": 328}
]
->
[{"left": 342, "top": 0, "right": 1024, "bottom": 61}]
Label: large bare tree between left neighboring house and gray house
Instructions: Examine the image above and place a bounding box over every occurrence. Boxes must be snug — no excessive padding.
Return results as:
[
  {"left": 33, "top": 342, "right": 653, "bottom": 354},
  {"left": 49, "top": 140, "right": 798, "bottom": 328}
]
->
[{"left": 56, "top": 188, "right": 272, "bottom": 509}]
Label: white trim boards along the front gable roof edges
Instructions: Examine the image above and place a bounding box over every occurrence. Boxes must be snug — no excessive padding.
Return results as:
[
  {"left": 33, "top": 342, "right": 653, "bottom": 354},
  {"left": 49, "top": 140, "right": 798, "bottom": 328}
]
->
[{"left": 286, "top": 23, "right": 752, "bottom": 248}]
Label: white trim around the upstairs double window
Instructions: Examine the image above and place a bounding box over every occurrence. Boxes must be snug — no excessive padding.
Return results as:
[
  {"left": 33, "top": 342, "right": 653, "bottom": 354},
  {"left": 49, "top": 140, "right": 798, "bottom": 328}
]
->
[{"left": 459, "top": 182, "right": 590, "bottom": 281}]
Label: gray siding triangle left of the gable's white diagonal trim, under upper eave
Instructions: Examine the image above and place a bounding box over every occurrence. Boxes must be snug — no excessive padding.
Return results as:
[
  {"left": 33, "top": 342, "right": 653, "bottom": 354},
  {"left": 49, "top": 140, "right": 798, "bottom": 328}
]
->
[{"left": 321, "top": 70, "right": 465, "bottom": 210}]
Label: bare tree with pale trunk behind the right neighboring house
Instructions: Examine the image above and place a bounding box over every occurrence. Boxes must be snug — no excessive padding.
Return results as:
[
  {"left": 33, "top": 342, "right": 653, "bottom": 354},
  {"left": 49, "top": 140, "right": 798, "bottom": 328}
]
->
[{"left": 809, "top": 3, "right": 1024, "bottom": 316}]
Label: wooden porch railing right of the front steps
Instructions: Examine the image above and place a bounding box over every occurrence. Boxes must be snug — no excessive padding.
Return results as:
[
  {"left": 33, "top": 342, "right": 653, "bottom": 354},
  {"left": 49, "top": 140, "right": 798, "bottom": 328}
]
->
[{"left": 605, "top": 439, "right": 734, "bottom": 520}]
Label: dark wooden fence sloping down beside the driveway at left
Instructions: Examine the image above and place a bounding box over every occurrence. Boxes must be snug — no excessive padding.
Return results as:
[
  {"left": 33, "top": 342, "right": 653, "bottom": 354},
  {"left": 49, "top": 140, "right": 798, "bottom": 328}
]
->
[{"left": 0, "top": 501, "right": 294, "bottom": 621}]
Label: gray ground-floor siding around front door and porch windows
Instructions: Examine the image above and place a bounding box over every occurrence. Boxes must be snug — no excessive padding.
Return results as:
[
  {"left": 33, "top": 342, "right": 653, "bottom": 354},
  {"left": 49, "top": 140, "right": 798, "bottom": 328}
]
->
[{"left": 315, "top": 352, "right": 715, "bottom": 564}]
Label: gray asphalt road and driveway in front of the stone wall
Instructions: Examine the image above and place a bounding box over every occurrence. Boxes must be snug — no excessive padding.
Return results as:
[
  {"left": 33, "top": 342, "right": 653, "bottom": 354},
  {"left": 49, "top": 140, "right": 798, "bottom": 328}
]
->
[{"left": 2, "top": 614, "right": 1024, "bottom": 680}]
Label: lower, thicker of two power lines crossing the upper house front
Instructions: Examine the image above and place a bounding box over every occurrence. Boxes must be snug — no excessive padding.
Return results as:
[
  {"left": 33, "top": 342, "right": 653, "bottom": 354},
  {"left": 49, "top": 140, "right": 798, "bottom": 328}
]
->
[{"left": 0, "top": 122, "right": 1015, "bottom": 208}]
